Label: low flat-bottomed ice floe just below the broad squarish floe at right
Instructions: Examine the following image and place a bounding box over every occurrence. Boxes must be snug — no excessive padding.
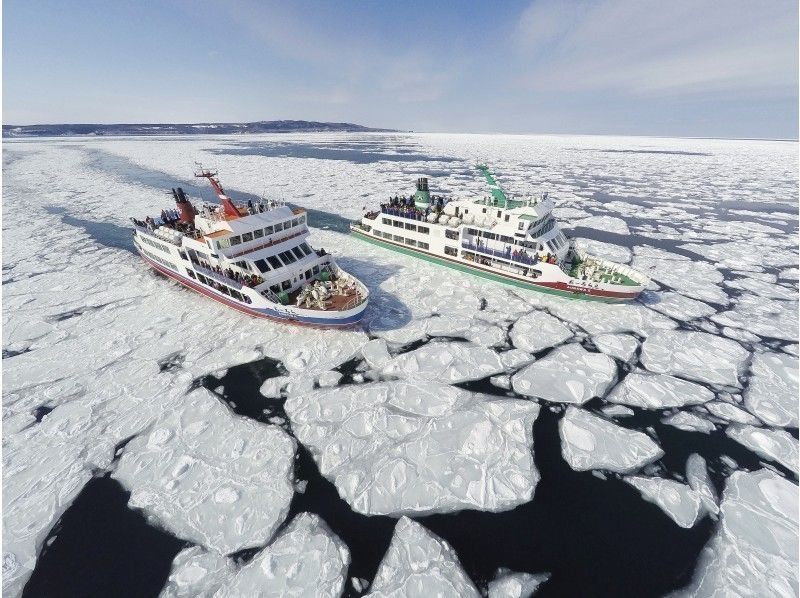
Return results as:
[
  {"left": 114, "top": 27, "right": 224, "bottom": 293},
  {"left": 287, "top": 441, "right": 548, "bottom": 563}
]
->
[{"left": 606, "top": 372, "right": 714, "bottom": 409}]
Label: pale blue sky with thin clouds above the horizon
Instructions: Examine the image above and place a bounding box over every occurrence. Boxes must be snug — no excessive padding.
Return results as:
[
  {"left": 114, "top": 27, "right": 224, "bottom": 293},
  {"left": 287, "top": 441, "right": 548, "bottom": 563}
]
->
[{"left": 2, "top": 0, "right": 798, "bottom": 139}]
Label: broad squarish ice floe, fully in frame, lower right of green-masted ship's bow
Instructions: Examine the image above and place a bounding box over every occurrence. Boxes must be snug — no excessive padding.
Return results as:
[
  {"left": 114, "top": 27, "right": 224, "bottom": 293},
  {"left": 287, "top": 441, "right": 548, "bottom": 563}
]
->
[{"left": 641, "top": 330, "right": 750, "bottom": 387}]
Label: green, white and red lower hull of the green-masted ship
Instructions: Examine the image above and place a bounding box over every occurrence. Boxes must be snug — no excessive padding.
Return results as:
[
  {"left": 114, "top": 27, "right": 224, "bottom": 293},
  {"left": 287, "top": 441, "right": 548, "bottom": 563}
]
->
[{"left": 351, "top": 227, "right": 643, "bottom": 303}]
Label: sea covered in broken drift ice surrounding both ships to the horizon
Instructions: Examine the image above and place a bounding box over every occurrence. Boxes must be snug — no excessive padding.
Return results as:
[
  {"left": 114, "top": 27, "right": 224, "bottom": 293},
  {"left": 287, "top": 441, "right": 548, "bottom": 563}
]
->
[{"left": 2, "top": 133, "right": 799, "bottom": 598}]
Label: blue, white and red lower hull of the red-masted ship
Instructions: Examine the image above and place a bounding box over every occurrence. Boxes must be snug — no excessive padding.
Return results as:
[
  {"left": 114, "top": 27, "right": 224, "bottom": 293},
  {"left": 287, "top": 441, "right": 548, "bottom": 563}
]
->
[{"left": 137, "top": 247, "right": 367, "bottom": 328}]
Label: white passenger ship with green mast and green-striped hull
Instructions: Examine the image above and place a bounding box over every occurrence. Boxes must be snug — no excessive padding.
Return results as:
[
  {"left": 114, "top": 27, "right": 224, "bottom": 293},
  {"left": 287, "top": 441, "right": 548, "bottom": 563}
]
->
[{"left": 350, "top": 165, "right": 649, "bottom": 301}]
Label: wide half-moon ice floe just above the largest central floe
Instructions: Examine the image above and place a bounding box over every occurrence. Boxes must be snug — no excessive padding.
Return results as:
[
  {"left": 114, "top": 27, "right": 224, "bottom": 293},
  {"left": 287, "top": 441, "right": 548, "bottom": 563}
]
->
[{"left": 381, "top": 341, "right": 505, "bottom": 384}]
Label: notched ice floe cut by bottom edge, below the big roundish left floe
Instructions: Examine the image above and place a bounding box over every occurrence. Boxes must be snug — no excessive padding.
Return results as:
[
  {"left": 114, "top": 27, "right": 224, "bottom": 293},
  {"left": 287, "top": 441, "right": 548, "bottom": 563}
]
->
[{"left": 161, "top": 513, "right": 350, "bottom": 598}]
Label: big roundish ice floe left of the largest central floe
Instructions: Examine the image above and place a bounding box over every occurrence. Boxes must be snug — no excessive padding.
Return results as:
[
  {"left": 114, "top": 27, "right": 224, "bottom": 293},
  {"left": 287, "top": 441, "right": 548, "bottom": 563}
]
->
[{"left": 113, "top": 389, "right": 295, "bottom": 553}]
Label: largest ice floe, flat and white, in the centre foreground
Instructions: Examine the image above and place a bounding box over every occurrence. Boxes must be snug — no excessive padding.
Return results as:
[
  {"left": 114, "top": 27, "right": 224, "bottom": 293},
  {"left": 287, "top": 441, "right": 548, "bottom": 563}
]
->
[{"left": 286, "top": 381, "right": 539, "bottom": 515}]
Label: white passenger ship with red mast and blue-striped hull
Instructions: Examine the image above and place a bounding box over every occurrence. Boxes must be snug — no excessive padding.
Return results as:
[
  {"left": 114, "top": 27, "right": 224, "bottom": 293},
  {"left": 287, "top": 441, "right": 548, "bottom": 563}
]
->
[{"left": 131, "top": 167, "right": 369, "bottom": 327}]
